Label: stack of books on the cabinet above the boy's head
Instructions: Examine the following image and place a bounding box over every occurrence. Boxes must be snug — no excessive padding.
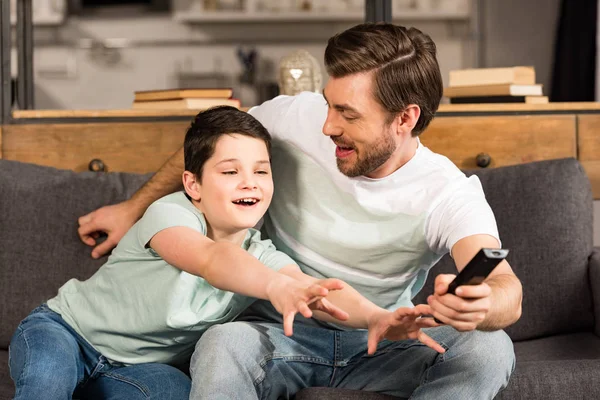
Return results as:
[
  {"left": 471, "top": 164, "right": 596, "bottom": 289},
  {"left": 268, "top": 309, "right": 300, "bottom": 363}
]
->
[{"left": 132, "top": 88, "right": 240, "bottom": 110}]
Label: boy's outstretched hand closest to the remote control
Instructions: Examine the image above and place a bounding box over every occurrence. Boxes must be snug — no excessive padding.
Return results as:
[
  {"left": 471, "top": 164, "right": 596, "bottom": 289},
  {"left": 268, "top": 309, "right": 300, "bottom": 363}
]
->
[{"left": 368, "top": 304, "right": 446, "bottom": 354}]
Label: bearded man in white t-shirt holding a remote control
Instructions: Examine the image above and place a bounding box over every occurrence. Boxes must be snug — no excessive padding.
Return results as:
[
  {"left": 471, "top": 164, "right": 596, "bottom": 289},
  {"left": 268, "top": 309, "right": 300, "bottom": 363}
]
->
[{"left": 79, "top": 24, "right": 522, "bottom": 399}]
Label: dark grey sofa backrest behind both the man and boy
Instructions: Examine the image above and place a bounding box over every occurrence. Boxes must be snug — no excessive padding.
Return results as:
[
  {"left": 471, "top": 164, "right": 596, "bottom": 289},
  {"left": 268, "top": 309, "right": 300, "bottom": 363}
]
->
[{"left": 0, "top": 159, "right": 594, "bottom": 348}]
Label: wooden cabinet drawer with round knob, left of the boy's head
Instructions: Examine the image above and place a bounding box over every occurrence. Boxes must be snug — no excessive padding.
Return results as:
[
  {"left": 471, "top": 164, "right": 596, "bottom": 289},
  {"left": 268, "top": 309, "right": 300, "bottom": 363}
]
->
[{"left": 2, "top": 121, "right": 189, "bottom": 173}]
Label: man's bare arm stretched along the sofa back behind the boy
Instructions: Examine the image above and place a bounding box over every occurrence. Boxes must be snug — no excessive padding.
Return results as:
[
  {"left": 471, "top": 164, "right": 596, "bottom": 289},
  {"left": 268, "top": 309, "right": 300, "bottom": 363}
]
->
[{"left": 78, "top": 147, "right": 184, "bottom": 258}]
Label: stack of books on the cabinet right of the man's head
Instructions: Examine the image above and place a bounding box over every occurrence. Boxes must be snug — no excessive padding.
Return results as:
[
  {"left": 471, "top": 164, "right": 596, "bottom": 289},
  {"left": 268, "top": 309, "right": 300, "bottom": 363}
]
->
[{"left": 444, "top": 67, "right": 548, "bottom": 104}]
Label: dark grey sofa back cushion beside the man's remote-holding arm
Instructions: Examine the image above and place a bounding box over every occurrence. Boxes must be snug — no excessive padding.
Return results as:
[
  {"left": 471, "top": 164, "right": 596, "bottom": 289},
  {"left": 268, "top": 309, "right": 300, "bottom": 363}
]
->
[{"left": 413, "top": 159, "right": 594, "bottom": 341}]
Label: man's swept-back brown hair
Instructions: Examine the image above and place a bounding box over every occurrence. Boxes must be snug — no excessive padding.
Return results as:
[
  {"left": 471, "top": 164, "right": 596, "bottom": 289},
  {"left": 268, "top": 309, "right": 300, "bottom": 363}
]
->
[{"left": 325, "top": 23, "right": 443, "bottom": 136}]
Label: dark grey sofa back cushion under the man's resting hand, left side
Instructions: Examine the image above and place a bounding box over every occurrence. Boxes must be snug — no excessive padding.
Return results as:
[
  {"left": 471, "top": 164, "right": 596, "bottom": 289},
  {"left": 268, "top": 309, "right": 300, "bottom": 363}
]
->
[{"left": 0, "top": 160, "right": 148, "bottom": 349}]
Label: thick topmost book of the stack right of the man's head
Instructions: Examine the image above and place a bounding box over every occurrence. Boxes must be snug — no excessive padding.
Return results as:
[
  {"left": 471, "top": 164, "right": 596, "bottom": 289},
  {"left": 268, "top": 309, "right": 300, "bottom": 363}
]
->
[{"left": 448, "top": 67, "right": 535, "bottom": 87}]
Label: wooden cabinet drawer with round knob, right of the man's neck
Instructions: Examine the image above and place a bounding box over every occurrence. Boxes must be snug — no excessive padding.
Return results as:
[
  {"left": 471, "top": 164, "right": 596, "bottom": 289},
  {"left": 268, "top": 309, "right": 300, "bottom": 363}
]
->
[{"left": 421, "top": 115, "right": 577, "bottom": 169}]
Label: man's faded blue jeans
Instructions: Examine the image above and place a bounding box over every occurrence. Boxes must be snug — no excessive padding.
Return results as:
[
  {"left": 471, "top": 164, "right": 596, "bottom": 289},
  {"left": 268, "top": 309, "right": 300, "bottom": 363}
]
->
[{"left": 190, "top": 302, "right": 515, "bottom": 400}]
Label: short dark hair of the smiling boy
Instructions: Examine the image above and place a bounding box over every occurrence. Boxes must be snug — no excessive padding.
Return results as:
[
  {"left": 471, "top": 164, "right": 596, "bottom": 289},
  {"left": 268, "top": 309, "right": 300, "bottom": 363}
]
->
[{"left": 183, "top": 106, "right": 271, "bottom": 180}]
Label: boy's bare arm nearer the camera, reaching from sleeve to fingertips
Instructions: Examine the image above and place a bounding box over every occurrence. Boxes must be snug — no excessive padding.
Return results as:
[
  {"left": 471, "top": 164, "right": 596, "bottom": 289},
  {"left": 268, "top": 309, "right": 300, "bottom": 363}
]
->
[{"left": 150, "top": 226, "right": 344, "bottom": 336}]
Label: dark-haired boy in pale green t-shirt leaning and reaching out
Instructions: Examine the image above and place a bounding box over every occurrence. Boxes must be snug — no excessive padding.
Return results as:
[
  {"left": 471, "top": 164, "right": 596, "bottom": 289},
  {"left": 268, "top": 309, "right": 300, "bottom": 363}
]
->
[{"left": 9, "top": 107, "right": 348, "bottom": 399}]
